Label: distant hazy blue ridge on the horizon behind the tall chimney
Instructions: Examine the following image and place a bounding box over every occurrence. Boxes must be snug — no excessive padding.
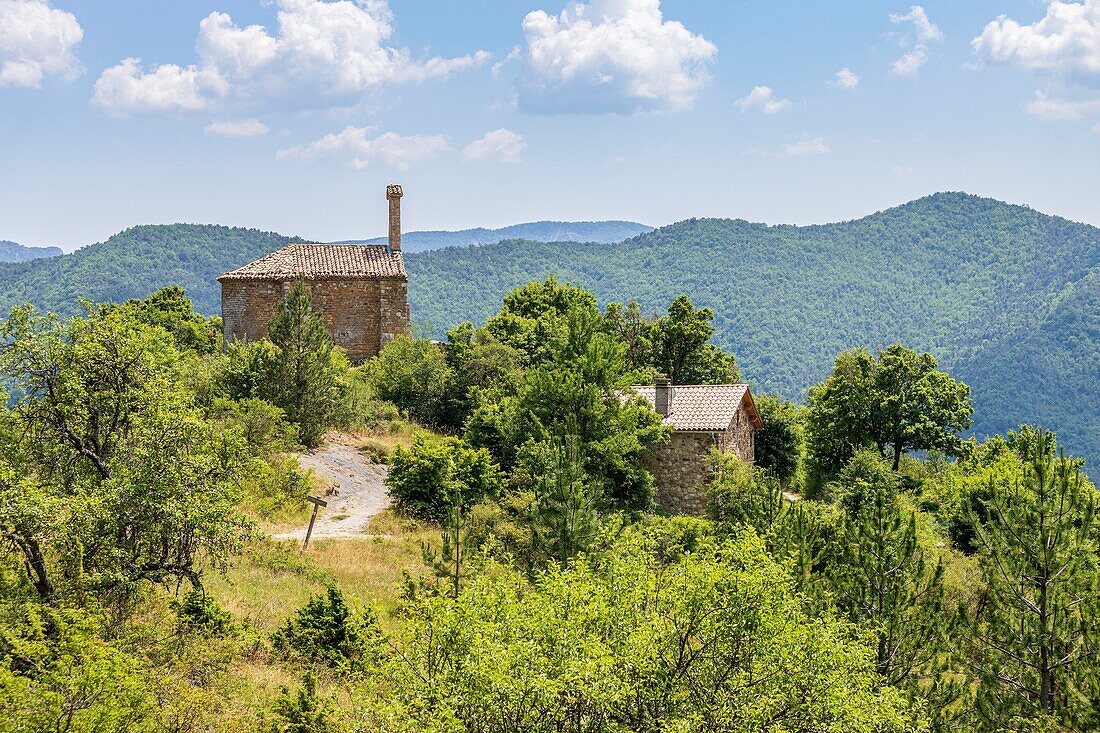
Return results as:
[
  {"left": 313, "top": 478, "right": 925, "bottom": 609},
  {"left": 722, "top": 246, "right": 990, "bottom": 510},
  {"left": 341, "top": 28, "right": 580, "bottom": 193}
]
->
[{"left": 339, "top": 216, "right": 653, "bottom": 252}]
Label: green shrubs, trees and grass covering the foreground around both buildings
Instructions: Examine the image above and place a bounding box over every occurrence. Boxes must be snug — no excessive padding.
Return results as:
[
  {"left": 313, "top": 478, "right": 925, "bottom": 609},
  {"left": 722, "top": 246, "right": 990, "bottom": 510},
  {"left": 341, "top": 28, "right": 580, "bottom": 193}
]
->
[{"left": 0, "top": 278, "right": 1100, "bottom": 733}]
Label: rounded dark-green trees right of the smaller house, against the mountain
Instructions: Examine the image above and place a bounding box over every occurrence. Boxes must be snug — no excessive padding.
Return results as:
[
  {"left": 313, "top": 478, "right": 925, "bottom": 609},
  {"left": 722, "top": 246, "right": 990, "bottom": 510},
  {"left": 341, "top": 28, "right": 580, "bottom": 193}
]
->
[{"left": 805, "top": 344, "right": 972, "bottom": 481}]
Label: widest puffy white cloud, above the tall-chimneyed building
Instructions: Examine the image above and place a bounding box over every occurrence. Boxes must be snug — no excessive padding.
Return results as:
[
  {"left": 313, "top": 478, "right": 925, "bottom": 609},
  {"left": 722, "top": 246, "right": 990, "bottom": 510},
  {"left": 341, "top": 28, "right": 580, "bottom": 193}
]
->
[{"left": 92, "top": 0, "right": 490, "bottom": 114}]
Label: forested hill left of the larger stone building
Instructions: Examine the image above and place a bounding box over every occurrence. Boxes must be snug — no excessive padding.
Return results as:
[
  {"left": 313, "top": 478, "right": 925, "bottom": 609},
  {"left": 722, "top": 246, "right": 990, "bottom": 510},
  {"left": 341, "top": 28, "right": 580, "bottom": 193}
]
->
[{"left": 0, "top": 225, "right": 303, "bottom": 315}]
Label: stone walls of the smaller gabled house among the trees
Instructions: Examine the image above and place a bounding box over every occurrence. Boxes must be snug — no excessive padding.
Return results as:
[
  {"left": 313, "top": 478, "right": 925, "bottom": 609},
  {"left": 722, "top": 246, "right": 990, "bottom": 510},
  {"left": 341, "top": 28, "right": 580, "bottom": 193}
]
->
[{"left": 642, "top": 407, "right": 756, "bottom": 515}]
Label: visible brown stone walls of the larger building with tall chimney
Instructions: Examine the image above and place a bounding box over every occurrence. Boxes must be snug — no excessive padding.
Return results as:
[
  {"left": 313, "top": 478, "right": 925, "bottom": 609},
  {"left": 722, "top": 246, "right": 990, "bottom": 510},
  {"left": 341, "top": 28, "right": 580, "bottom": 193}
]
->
[{"left": 221, "top": 278, "right": 409, "bottom": 363}]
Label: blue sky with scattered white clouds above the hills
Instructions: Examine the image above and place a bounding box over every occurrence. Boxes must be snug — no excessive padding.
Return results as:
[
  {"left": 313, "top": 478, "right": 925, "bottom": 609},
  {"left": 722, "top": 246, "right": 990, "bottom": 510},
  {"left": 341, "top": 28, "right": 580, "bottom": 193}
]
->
[{"left": 0, "top": 0, "right": 1100, "bottom": 249}]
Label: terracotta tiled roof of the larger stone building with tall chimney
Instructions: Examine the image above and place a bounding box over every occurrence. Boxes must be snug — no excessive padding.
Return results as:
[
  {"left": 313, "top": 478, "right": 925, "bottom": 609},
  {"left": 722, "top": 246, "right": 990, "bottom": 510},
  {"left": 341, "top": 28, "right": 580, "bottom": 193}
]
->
[{"left": 218, "top": 244, "right": 408, "bottom": 282}]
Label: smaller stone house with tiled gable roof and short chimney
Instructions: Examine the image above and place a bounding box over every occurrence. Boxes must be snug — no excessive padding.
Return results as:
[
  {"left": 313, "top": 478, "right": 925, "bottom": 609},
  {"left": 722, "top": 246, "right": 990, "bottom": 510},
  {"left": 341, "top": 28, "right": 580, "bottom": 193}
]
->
[{"left": 630, "top": 382, "right": 763, "bottom": 514}]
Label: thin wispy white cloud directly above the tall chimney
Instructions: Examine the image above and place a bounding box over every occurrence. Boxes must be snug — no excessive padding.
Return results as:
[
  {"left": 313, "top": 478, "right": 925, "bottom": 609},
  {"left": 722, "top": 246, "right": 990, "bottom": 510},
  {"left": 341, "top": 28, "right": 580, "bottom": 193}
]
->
[{"left": 276, "top": 125, "right": 447, "bottom": 171}]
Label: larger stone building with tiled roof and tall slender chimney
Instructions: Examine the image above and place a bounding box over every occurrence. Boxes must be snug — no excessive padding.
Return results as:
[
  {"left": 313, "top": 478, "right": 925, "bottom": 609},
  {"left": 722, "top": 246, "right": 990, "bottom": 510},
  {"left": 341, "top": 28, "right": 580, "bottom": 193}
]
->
[{"left": 218, "top": 186, "right": 409, "bottom": 363}]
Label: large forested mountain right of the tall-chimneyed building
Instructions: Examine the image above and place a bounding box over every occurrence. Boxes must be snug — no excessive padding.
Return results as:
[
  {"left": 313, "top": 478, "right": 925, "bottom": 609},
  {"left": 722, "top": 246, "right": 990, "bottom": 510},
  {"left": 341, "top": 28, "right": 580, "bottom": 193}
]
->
[{"left": 406, "top": 194, "right": 1100, "bottom": 457}]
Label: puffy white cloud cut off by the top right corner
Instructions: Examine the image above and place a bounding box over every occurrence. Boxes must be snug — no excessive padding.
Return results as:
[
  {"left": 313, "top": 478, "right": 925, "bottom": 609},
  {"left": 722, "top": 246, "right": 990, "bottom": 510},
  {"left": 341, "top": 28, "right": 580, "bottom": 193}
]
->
[{"left": 970, "top": 0, "right": 1100, "bottom": 83}]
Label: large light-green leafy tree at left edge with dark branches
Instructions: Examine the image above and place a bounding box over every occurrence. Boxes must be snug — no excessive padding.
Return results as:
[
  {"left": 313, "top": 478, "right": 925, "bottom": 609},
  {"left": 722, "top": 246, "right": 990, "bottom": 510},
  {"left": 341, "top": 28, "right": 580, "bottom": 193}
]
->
[{"left": 0, "top": 301, "right": 248, "bottom": 599}]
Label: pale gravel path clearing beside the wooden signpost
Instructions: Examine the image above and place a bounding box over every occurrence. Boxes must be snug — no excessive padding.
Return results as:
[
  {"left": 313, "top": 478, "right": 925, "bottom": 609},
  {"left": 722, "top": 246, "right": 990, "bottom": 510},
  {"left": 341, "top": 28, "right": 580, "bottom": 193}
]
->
[{"left": 275, "top": 442, "right": 389, "bottom": 540}]
